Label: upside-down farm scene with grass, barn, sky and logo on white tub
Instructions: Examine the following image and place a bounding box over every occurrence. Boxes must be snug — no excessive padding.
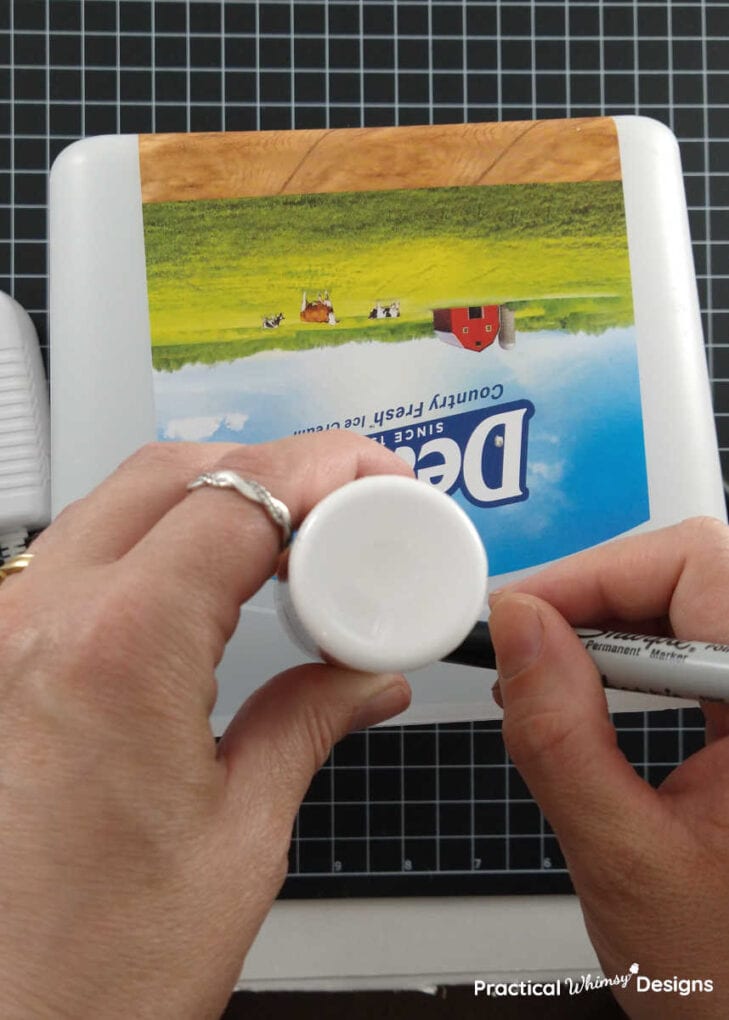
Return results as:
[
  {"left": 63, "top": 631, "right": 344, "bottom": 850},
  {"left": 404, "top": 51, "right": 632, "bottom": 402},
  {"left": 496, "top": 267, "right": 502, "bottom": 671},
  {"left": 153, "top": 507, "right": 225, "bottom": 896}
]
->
[{"left": 144, "top": 125, "right": 649, "bottom": 574}]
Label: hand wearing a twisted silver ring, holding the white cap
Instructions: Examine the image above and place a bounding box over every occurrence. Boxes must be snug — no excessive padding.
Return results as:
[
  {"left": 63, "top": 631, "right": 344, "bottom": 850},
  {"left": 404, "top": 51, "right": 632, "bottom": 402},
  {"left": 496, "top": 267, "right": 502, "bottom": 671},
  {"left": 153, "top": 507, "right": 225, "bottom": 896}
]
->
[{"left": 0, "top": 435, "right": 410, "bottom": 1020}]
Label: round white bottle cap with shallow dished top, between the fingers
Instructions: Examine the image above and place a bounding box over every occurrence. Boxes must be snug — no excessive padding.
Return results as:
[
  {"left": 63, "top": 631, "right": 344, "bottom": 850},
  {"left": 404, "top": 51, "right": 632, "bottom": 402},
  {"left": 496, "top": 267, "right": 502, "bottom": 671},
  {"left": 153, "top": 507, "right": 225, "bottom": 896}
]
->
[{"left": 279, "top": 475, "right": 488, "bottom": 672}]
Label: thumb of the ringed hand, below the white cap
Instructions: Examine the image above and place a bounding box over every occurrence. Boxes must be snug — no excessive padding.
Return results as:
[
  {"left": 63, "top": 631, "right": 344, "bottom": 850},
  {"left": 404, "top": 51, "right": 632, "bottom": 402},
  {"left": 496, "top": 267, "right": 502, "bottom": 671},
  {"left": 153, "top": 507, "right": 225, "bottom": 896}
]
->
[{"left": 218, "top": 663, "right": 410, "bottom": 839}]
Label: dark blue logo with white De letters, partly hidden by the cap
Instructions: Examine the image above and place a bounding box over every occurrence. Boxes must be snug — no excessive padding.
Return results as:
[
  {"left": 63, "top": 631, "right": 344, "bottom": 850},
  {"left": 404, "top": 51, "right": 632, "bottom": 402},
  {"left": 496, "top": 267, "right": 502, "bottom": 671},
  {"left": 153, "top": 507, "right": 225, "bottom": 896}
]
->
[{"left": 371, "top": 400, "right": 534, "bottom": 507}]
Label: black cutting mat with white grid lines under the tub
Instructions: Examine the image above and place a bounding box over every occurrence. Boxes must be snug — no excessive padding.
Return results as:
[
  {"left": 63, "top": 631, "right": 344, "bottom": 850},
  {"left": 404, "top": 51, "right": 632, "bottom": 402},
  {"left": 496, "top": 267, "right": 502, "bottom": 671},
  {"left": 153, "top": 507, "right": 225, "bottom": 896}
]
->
[{"left": 0, "top": 0, "right": 729, "bottom": 897}]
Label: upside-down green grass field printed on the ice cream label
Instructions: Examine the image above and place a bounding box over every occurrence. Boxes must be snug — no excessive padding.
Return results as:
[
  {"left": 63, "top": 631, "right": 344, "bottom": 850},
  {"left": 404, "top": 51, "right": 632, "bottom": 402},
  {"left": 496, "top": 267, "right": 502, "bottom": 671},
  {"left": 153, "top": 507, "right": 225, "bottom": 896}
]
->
[{"left": 144, "top": 183, "right": 632, "bottom": 367}]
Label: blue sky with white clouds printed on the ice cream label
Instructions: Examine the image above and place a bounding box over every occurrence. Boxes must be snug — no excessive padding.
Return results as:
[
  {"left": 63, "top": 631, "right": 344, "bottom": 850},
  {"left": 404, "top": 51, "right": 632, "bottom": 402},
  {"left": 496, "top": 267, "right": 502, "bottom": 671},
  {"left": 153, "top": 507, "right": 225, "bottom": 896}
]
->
[{"left": 154, "top": 327, "right": 649, "bottom": 575}]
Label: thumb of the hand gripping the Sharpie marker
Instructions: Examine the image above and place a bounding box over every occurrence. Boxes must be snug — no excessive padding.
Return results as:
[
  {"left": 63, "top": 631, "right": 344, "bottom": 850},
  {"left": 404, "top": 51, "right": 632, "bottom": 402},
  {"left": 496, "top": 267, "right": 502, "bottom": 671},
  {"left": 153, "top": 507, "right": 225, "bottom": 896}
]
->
[{"left": 488, "top": 592, "right": 656, "bottom": 854}]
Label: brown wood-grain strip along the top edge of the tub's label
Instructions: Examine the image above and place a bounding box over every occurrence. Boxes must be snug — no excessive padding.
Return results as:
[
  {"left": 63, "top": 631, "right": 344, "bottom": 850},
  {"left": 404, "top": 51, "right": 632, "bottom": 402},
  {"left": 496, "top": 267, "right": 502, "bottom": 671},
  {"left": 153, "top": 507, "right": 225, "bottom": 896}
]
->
[{"left": 140, "top": 117, "right": 620, "bottom": 202}]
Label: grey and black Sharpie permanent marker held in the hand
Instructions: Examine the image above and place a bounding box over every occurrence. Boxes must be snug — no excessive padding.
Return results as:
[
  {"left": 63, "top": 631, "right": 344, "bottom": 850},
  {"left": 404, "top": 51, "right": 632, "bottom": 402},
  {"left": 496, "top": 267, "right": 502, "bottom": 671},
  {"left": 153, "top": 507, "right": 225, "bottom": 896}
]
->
[{"left": 442, "top": 622, "right": 729, "bottom": 703}]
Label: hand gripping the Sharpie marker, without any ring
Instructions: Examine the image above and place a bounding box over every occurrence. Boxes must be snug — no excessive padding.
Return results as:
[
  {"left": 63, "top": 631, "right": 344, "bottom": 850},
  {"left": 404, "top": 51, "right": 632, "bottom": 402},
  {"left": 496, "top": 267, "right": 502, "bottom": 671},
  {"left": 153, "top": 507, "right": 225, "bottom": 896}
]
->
[{"left": 489, "top": 518, "right": 729, "bottom": 1020}]
